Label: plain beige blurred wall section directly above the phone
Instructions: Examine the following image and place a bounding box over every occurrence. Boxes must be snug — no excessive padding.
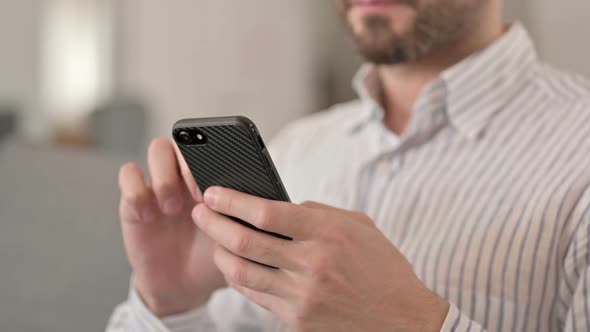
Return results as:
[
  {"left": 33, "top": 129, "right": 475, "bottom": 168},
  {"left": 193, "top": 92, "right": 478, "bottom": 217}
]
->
[{"left": 116, "top": 0, "right": 324, "bottom": 137}]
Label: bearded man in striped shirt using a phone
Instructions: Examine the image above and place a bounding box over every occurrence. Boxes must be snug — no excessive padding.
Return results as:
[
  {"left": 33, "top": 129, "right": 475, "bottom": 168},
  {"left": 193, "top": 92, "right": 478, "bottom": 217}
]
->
[{"left": 109, "top": 0, "right": 590, "bottom": 331}]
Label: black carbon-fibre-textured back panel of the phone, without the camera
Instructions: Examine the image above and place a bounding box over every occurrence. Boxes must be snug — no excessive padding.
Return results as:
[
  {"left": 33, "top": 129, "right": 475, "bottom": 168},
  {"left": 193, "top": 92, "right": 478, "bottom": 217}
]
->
[{"left": 179, "top": 124, "right": 288, "bottom": 200}]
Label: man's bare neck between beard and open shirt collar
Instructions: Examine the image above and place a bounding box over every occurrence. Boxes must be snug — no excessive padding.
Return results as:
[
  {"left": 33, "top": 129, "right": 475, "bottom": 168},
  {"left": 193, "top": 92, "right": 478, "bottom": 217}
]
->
[{"left": 378, "top": 14, "right": 504, "bottom": 136}]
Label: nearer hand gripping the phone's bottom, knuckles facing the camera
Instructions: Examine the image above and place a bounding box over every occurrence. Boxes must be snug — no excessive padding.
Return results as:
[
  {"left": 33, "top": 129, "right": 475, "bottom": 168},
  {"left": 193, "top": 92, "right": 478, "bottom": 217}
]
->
[{"left": 193, "top": 188, "right": 449, "bottom": 331}]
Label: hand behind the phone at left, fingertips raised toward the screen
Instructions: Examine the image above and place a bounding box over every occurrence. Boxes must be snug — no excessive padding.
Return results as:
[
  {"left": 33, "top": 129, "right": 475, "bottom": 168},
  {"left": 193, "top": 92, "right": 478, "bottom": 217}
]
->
[{"left": 119, "top": 139, "right": 226, "bottom": 317}]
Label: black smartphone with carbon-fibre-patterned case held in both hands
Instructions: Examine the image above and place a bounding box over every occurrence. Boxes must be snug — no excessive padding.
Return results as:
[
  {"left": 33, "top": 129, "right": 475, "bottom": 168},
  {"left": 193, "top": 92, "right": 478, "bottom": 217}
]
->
[{"left": 172, "top": 116, "right": 290, "bottom": 240}]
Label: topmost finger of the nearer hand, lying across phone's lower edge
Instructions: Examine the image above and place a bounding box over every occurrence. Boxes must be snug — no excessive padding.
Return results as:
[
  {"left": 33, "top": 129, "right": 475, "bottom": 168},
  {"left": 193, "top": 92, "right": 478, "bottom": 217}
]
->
[{"left": 204, "top": 187, "right": 314, "bottom": 240}]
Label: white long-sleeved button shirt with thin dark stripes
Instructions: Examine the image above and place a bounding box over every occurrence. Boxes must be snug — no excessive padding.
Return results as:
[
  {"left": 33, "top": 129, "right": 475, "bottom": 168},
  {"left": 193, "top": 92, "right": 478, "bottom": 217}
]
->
[{"left": 109, "top": 23, "right": 590, "bottom": 332}]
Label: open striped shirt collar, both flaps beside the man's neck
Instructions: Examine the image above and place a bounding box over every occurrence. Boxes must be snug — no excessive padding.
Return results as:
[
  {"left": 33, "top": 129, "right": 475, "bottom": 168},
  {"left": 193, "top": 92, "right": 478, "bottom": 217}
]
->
[{"left": 349, "top": 22, "right": 538, "bottom": 138}]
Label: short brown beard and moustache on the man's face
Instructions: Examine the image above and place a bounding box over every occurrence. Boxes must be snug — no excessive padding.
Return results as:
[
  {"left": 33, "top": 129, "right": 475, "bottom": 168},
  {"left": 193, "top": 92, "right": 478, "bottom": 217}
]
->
[{"left": 340, "top": 0, "right": 483, "bottom": 65}]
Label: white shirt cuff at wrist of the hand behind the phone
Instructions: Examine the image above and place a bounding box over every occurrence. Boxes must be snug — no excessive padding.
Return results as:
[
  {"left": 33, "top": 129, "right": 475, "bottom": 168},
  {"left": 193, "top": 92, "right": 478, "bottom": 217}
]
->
[{"left": 128, "top": 286, "right": 215, "bottom": 332}]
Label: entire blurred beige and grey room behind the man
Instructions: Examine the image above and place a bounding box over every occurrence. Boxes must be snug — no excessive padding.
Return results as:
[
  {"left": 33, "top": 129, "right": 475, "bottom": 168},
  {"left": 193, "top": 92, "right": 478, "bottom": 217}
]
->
[{"left": 0, "top": 0, "right": 590, "bottom": 331}]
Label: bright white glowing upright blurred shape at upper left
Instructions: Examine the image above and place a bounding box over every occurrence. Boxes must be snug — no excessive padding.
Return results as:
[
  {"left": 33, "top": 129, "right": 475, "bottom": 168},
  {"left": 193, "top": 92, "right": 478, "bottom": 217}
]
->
[{"left": 41, "top": 0, "right": 112, "bottom": 132}]
